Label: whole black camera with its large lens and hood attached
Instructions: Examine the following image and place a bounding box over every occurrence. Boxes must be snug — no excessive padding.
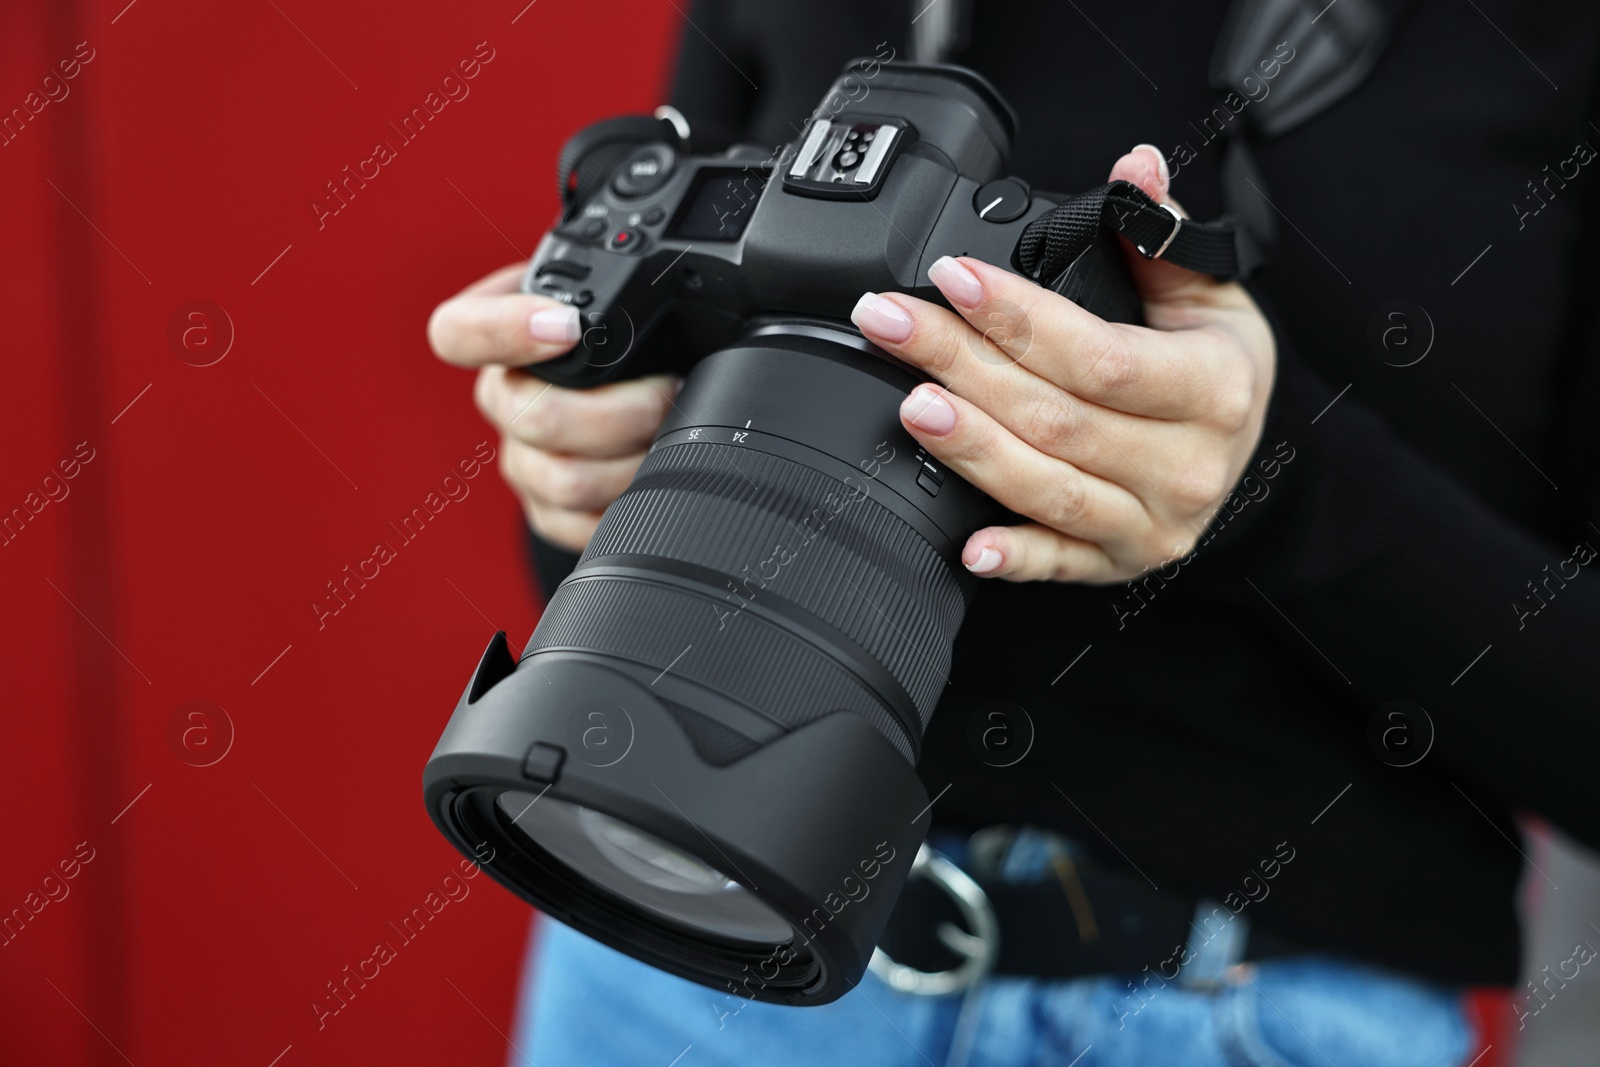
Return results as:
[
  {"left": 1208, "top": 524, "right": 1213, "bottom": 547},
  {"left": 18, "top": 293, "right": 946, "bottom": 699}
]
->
[{"left": 424, "top": 61, "right": 1145, "bottom": 1005}]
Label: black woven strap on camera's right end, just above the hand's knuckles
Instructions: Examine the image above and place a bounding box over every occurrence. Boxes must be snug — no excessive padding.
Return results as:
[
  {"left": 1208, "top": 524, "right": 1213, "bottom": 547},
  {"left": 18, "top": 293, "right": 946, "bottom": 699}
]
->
[{"left": 1016, "top": 181, "right": 1242, "bottom": 283}]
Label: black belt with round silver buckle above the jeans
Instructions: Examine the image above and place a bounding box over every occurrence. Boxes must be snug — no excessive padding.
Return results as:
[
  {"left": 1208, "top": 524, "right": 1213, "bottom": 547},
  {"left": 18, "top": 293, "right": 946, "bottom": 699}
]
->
[{"left": 872, "top": 846, "right": 1306, "bottom": 993}]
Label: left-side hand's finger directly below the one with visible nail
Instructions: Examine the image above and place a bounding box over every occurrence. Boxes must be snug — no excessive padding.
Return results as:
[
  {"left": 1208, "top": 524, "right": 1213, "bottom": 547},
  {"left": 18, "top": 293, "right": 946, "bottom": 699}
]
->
[{"left": 474, "top": 366, "right": 678, "bottom": 459}]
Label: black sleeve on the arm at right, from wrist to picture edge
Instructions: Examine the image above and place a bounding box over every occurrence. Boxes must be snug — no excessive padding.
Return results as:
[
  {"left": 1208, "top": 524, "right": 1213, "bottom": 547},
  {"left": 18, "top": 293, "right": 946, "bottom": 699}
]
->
[{"left": 1187, "top": 321, "right": 1600, "bottom": 846}]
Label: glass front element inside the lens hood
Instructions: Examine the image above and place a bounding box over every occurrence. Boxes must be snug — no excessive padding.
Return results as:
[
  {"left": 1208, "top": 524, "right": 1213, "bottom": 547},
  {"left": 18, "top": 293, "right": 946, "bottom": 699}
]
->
[{"left": 494, "top": 790, "right": 794, "bottom": 945}]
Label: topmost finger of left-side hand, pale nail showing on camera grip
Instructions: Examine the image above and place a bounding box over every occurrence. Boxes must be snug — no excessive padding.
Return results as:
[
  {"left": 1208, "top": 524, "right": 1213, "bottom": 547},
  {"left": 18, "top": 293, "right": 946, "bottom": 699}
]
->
[{"left": 427, "top": 279, "right": 581, "bottom": 366}]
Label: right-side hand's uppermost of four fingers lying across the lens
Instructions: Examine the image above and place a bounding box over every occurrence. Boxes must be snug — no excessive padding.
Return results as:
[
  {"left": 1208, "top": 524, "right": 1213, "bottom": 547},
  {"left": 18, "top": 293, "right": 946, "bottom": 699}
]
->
[{"left": 915, "top": 256, "right": 1248, "bottom": 419}]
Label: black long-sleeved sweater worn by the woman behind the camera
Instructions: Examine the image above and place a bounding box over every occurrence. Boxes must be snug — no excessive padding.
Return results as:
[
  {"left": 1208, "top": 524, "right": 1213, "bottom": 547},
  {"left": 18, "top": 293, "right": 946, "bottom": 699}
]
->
[{"left": 536, "top": 0, "right": 1600, "bottom": 984}]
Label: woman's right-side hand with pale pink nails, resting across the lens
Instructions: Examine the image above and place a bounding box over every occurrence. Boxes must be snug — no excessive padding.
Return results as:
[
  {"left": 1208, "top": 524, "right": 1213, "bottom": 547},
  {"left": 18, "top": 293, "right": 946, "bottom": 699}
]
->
[{"left": 851, "top": 146, "right": 1277, "bottom": 584}]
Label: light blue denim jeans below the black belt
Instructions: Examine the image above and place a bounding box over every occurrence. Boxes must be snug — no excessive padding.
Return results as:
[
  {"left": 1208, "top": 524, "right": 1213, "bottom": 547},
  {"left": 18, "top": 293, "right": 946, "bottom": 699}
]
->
[{"left": 510, "top": 918, "right": 1474, "bottom": 1067}]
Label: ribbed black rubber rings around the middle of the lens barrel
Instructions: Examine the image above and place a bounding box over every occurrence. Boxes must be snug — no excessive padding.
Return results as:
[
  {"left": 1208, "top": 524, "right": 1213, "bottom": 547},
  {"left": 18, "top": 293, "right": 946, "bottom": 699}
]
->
[{"left": 528, "top": 443, "right": 965, "bottom": 758}]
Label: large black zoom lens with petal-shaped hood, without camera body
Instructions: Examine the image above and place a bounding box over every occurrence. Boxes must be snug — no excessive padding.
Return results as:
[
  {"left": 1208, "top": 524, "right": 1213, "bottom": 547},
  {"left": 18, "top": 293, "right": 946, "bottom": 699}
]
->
[{"left": 424, "top": 320, "right": 997, "bottom": 1005}]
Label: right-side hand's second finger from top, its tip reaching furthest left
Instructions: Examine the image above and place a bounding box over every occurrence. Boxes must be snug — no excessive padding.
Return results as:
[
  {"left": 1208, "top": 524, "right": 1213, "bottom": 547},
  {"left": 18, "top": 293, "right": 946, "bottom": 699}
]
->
[{"left": 854, "top": 294, "right": 1186, "bottom": 498}]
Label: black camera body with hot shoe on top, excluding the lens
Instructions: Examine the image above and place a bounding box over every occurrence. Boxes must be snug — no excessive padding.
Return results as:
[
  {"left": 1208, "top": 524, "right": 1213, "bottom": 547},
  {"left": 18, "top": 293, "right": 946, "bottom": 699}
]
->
[{"left": 522, "top": 59, "right": 1141, "bottom": 387}]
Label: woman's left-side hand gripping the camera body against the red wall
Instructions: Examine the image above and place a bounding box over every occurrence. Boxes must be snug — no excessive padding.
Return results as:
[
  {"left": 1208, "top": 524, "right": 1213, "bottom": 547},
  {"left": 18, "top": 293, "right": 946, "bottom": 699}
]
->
[{"left": 427, "top": 264, "right": 678, "bottom": 552}]
